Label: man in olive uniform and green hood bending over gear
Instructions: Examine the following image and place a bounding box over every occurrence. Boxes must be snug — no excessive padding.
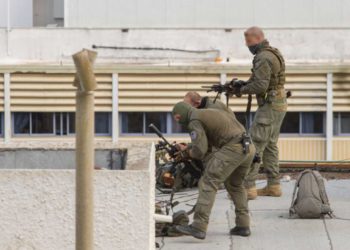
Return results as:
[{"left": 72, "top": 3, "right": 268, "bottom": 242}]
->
[{"left": 173, "top": 102, "right": 255, "bottom": 239}]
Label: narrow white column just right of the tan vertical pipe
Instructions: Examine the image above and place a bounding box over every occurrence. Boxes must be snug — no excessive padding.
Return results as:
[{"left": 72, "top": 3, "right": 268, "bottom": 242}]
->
[{"left": 112, "top": 73, "right": 119, "bottom": 143}]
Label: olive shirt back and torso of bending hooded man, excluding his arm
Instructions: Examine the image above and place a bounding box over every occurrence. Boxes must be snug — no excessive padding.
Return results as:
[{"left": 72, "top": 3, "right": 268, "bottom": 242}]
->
[{"left": 190, "top": 109, "right": 245, "bottom": 148}]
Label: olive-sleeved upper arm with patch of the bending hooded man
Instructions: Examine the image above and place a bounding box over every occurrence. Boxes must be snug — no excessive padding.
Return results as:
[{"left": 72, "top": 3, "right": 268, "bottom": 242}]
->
[{"left": 188, "top": 121, "right": 208, "bottom": 160}]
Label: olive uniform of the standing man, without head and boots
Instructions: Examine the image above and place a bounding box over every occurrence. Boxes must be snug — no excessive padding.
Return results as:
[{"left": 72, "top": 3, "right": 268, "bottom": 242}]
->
[{"left": 241, "top": 40, "right": 287, "bottom": 188}]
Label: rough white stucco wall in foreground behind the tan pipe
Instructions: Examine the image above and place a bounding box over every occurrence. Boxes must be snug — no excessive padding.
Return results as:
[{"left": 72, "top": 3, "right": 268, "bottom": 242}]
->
[{"left": 0, "top": 169, "right": 155, "bottom": 250}]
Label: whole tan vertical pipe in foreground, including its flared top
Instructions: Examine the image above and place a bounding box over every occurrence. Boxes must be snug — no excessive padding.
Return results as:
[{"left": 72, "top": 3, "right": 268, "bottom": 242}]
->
[{"left": 73, "top": 50, "right": 97, "bottom": 250}]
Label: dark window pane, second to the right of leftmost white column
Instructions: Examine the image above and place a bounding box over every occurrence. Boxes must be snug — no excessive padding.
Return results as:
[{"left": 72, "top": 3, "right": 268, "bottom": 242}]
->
[{"left": 32, "top": 113, "right": 54, "bottom": 134}]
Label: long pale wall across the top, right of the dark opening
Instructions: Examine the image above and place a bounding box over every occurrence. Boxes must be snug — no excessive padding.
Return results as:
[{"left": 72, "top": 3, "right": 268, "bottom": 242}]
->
[{"left": 65, "top": 0, "right": 350, "bottom": 28}]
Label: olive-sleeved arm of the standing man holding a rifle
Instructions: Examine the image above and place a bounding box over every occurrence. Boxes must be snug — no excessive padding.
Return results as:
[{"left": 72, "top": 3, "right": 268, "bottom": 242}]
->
[{"left": 240, "top": 55, "right": 272, "bottom": 94}]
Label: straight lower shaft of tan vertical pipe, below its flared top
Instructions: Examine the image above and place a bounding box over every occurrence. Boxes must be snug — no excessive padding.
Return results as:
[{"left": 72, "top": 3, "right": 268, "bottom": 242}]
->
[{"left": 75, "top": 91, "right": 95, "bottom": 250}]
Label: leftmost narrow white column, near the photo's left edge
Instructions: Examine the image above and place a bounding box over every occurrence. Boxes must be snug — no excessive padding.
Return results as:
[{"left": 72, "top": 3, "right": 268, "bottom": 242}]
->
[{"left": 4, "top": 73, "right": 11, "bottom": 143}]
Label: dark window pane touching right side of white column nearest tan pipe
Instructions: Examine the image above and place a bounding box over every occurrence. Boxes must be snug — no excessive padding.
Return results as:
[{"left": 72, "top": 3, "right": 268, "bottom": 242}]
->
[{"left": 122, "top": 112, "right": 143, "bottom": 134}]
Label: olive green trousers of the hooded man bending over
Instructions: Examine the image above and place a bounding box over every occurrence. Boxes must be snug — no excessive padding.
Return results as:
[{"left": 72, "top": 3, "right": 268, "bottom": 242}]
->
[{"left": 192, "top": 143, "right": 255, "bottom": 232}]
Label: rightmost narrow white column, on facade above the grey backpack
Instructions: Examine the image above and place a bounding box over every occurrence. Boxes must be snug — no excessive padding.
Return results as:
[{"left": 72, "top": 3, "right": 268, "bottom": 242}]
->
[{"left": 326, "top": 73, "right": 333, "bottom": 161}]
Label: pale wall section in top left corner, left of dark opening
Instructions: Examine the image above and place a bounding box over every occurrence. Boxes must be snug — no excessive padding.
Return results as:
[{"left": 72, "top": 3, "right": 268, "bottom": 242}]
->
[{"left": 0, "top": 0, "right": 33, "bottom": 27}]
